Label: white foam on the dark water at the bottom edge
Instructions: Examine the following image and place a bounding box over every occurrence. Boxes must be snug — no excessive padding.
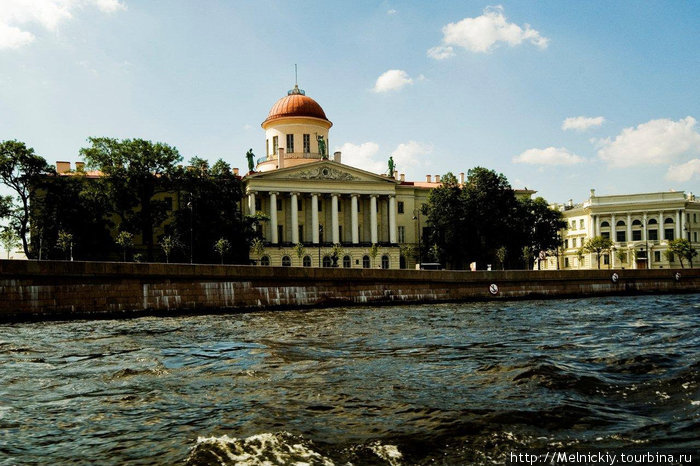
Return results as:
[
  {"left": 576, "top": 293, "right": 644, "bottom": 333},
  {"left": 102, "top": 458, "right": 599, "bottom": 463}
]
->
[{"left": 189, "top": 432, "right": 333, "bottom": 466}]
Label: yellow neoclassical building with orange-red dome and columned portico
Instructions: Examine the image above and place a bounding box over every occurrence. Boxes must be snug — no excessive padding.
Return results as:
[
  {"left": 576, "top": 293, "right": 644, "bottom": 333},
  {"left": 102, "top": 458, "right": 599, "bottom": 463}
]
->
[{"left": 243, "top": 86, "right": 442, "bottom": 269}]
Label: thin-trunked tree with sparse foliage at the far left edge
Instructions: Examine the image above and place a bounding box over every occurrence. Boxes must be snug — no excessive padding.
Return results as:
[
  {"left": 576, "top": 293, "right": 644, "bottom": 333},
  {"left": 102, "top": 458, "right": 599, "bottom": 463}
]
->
[{"left": 0, "top": 141, "right": 55, "bottom": 257}]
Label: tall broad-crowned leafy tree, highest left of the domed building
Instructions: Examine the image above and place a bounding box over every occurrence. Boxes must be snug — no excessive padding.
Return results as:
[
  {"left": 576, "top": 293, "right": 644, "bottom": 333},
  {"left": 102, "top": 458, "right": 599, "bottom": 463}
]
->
[{"left": 80, "top": 137, "right": 182, "bottom": 260}]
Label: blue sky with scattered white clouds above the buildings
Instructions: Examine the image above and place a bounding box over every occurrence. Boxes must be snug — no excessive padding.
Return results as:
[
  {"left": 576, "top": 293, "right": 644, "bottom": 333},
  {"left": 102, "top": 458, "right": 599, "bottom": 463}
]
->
[{"left": 0, "top": 0, "right": 700, "bottom": 202}]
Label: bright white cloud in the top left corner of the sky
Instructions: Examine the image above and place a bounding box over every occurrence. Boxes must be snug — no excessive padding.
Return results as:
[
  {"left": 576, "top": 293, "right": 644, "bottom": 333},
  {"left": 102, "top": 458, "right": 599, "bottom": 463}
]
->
[{"left": 0, "top": 0, "right": 126, "bottom": 50}]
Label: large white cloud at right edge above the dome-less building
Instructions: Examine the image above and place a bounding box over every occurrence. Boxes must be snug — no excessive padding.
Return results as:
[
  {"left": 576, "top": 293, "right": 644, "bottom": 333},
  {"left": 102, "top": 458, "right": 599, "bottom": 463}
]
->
[{"left": 598, "top": 116, "right": 700, "bottom": 167}]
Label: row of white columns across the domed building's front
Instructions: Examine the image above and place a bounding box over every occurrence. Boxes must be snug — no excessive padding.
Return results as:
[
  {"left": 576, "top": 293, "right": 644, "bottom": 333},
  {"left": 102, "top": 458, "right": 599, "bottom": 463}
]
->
[{"left": 248, "top": 191, "right": 397, "bottom": 244}]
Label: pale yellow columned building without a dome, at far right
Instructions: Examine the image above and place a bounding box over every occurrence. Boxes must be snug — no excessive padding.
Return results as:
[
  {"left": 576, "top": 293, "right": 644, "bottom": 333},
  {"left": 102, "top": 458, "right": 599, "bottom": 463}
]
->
[{"left": 546, "top": 189, "right": 700, "bottom": 269}]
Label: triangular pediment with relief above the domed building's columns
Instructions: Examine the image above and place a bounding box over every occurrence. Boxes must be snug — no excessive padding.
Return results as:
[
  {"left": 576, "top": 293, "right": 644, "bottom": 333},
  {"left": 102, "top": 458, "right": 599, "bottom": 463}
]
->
[{"left": 246, "top": 160, "right": 399, "bottom": 184}]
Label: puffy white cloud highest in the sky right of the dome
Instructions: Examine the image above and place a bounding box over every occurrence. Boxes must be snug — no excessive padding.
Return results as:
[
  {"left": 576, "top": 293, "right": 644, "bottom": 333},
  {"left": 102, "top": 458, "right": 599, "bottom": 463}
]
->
[{"left": 428, "top": 6, "right": 549, "bottom": 60}]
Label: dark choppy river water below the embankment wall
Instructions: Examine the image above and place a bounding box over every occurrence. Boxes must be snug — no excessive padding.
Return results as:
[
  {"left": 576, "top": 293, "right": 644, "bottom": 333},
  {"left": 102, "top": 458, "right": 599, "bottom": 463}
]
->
[{"left": 0, "top": 294, "right": 700, "bottom": 465}]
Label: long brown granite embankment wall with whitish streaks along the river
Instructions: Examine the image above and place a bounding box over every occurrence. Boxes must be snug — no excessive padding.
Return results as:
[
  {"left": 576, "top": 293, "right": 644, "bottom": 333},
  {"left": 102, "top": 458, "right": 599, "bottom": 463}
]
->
[{"left": 0, "top": 260, "right": 700, "bottom": 321}]
